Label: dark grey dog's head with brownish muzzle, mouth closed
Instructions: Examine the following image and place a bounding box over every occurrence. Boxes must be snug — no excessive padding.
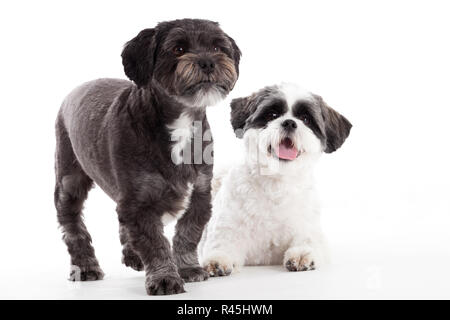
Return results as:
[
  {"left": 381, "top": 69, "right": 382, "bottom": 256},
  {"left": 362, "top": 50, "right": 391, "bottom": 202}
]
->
[{"left": 122, "top": 19, "right": 241, "bottom": 106}]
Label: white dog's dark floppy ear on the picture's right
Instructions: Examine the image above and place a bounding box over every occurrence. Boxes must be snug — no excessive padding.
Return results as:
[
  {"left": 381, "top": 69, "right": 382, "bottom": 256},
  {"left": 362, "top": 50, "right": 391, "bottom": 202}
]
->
[{"left": 316, "top": 96, "right": 352, "bottom": 153}]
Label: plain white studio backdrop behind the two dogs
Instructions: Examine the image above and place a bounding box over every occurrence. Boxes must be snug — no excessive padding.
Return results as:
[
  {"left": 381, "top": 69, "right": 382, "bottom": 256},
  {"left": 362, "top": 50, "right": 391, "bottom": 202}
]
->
[{"left": 0, "top": 0, "right": 450, "bottom": 298}]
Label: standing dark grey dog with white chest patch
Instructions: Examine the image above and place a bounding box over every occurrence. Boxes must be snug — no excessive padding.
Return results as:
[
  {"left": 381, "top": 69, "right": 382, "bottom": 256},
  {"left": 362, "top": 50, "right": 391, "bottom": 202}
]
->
[{"left": 55, "top": 19, "right": 241, "bottom": 295}]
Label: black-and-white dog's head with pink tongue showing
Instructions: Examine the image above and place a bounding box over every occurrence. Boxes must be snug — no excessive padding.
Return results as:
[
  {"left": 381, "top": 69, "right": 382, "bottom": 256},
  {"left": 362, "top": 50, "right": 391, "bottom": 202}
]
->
[{"left": 231, "top": 84, "right": 352, "bottom": 171}]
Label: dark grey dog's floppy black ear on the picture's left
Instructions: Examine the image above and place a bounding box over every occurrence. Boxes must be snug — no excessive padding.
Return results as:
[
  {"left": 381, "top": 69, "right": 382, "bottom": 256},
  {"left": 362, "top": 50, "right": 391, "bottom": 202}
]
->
[{"left": 122, "top": 29, "right": 156, "bottom": 87}]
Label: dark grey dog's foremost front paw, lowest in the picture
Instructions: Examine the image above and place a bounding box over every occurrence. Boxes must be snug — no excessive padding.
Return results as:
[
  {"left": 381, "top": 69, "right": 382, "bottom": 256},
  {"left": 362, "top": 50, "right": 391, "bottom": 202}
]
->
[{"left": 145, "top": 274, "right": 186, "bottom": 296}]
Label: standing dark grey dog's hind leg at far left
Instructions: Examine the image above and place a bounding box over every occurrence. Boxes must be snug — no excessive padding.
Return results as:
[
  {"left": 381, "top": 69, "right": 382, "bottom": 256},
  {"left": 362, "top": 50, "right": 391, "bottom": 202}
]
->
[{"left": 55, "top": 121, "right": 104, "bottom": 281}]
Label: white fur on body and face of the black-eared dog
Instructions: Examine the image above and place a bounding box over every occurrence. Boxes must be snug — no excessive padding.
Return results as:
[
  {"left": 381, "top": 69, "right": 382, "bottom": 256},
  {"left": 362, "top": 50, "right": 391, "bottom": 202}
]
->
[{"left": 200, "top": 85, "right": 326, "bottom": 270}]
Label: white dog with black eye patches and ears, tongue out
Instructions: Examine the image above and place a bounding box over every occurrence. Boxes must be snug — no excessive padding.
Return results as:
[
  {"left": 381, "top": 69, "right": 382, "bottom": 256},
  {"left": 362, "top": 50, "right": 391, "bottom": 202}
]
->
[{"left": 200, "top": 84, "right": 352, "bottom": 276}]
